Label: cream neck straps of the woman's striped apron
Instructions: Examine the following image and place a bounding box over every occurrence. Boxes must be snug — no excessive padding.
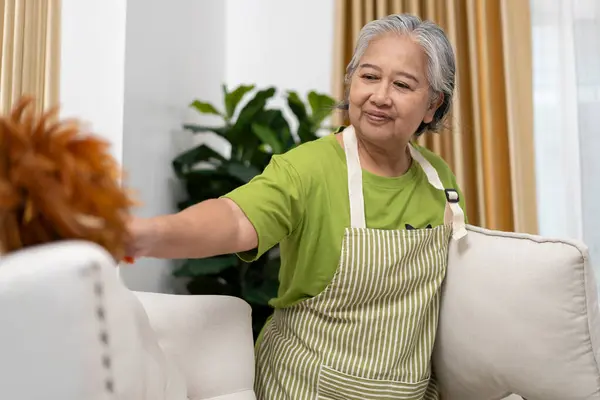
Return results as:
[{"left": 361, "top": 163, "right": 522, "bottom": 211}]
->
[{"left": 342, "top": 125, "right": 467, "bottom": 239}]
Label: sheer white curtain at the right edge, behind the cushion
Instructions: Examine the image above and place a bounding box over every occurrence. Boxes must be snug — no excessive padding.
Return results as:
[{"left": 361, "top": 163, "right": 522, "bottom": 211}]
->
[{"left": 530, "top": 0, "right": 600, "bottom": 273}]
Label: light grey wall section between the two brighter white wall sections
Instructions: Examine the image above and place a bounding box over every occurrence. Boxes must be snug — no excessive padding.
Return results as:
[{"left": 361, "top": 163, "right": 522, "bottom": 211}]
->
[{"left": 122, "top": 0, "right": 225, "bottom": 292}]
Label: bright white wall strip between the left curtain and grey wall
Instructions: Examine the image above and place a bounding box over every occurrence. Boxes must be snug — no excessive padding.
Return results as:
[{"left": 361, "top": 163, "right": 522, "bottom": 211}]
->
[{"left": 60, "top": 0, "right": 126, "bottom": 161}]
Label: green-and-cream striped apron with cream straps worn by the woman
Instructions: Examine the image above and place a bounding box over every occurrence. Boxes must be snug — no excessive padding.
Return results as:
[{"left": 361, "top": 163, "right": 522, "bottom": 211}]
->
[{"left": 255, "top": 127, "right": 466, "bottom": 400}]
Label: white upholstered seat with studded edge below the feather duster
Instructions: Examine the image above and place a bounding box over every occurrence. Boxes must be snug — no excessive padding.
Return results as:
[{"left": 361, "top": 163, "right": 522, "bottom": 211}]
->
[{"left": 0, "top": 242, "right": 255, "bottom": 400}]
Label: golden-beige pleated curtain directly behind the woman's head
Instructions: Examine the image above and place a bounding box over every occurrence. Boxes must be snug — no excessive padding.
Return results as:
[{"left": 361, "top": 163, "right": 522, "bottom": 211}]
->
[{"left": 333, "top": 0, "right": 537, "bottom": 233}]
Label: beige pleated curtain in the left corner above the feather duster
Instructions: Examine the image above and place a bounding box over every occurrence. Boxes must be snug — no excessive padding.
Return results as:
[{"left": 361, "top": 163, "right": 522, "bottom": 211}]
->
[{"left": 0, "top": 0, "right": 60, "bottom": 113}]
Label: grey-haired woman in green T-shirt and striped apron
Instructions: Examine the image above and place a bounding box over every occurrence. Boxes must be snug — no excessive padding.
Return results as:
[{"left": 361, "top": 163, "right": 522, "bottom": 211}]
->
[{"left": 131, "top": 14, "right": 464, "bottom": 399}]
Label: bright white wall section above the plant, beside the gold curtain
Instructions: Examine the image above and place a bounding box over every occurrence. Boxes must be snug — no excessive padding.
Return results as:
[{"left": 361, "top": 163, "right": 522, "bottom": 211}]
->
[{"left": 225, "top": 0, "right": 334, "bottom": 99}]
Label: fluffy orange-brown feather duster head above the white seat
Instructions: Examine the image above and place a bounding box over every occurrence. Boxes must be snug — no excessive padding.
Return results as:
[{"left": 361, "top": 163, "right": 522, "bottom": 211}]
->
[{"left": 0, "top": 98, "right": 134, "bottom": 260}]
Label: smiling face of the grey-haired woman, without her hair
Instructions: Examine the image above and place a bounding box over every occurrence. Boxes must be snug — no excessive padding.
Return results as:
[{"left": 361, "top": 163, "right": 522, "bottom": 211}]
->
[{"left": 349, "top": 33, "right": 441, "bottom": 147}]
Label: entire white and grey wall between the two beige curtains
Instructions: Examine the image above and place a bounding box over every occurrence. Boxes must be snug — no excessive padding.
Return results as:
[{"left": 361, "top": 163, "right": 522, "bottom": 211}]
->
[{"left": 61, "top": 0, "right": 334, "bottom": 292}]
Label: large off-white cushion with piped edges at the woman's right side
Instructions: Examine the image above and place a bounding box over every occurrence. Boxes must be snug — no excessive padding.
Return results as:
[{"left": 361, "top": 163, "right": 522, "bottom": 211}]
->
[{"left": 433, "top": 227, "right": 600, "bottom": 400}]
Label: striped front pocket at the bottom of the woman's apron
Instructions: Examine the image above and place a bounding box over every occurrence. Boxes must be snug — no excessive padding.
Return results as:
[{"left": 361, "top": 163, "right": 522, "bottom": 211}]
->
[{"left": 317, "top": 366, "right": 429, "bottom": 400}]
